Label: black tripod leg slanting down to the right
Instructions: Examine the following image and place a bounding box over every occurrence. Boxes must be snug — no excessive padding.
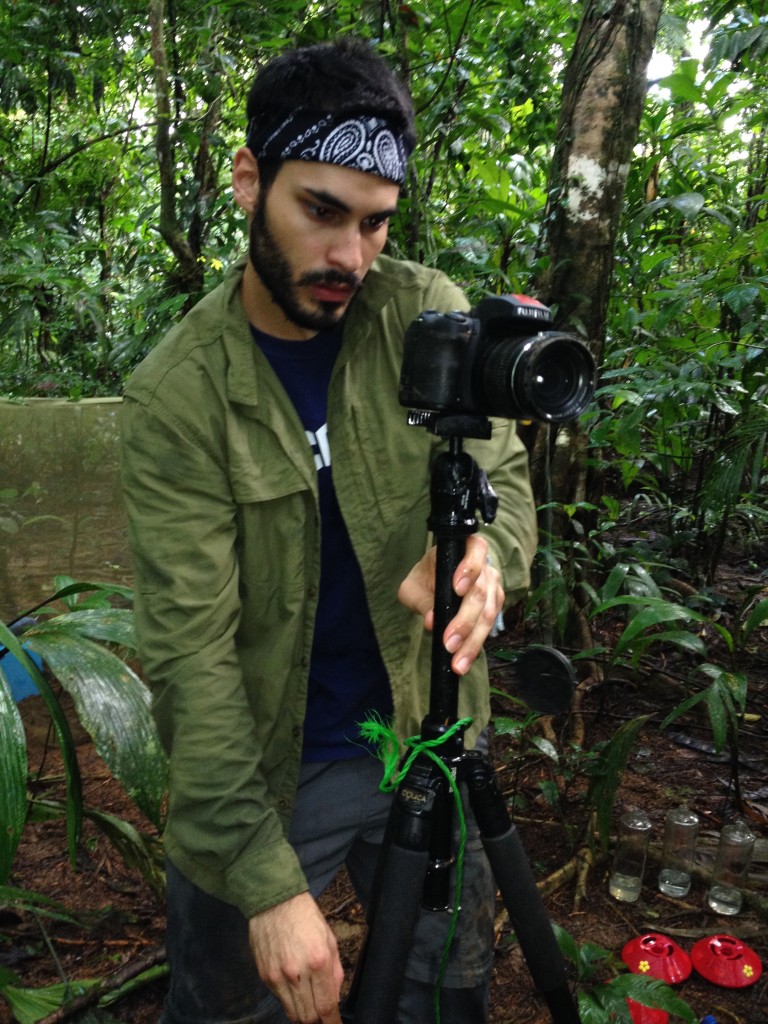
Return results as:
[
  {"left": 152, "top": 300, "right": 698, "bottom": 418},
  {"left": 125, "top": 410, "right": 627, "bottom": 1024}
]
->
[{"left": 465, "top": 752, "right": 581, "bottom": 1024}]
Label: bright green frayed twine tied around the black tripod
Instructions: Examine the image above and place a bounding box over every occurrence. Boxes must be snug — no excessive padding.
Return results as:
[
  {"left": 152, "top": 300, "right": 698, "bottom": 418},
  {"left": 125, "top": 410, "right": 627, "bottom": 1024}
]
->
[{"left": 359, "top": 716, "right": 472, "bottom": 1024}]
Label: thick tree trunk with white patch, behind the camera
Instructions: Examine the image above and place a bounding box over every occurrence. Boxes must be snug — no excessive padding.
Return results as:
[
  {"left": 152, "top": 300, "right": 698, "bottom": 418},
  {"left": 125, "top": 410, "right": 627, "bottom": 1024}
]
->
[{"left": 530, "top": 0, "right": 660, "bottom": 503}]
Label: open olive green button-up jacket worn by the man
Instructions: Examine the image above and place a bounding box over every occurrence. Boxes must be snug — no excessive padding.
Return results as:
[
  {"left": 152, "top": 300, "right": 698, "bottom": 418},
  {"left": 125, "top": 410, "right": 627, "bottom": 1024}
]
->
[{"left": 122, "top": 251, "right": 536, "bottom": 916}]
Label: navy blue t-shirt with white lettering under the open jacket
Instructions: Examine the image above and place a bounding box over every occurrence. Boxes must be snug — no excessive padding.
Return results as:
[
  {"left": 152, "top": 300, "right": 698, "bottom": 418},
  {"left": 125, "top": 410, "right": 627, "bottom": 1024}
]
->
[{"left": 256, "top": 327, "right": 392, "bottom": 761}]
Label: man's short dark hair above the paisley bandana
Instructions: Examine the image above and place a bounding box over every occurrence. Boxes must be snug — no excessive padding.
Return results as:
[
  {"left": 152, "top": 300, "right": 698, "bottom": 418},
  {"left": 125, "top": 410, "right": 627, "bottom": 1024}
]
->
[{"left": 246, "top": 36, "right": 416, "bottom": 187}]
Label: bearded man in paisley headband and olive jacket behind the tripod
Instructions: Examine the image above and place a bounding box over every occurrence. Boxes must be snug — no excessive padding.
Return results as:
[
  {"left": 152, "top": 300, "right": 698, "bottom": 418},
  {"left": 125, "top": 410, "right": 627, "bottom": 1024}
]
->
[{"left": 123, "top": 39, "right": 537, "bottom": 1024}]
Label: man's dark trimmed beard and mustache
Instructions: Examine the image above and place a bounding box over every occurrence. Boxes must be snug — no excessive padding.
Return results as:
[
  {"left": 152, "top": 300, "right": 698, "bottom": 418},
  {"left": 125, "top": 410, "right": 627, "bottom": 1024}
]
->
[{"left": 249, "top": 195, "right": 362, "bottom": 331}]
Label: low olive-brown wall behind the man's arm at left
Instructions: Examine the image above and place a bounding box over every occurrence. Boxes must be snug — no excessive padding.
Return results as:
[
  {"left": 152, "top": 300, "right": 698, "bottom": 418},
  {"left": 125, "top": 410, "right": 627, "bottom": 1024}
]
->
[{"left": 0, "top": 398, "right": 131, "bottom": 623}]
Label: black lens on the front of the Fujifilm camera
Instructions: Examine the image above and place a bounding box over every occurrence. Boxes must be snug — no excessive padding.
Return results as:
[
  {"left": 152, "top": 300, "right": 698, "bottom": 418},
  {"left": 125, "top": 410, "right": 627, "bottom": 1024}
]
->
[{"left": 475, "top": 331, "right": 595, "bottom": 423}]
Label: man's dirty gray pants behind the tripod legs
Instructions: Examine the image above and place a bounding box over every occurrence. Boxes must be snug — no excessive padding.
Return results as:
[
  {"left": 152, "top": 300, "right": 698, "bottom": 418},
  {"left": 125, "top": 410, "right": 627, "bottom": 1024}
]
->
[{"left": 161, "top": 757, "right": 495, "bottom": 1024}]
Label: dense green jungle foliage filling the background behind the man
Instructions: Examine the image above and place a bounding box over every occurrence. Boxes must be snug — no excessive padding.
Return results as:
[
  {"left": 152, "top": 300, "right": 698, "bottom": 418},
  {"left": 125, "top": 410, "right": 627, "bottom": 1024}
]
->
[{"left": 0, "top": 0, "right": 768, "bottom": 1019}]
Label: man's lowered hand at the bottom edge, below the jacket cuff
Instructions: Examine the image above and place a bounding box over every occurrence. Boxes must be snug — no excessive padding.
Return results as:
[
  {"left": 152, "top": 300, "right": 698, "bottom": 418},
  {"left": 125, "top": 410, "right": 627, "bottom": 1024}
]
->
[{"left": 249, "top": 893, "right": 344, "bottom": 1024}]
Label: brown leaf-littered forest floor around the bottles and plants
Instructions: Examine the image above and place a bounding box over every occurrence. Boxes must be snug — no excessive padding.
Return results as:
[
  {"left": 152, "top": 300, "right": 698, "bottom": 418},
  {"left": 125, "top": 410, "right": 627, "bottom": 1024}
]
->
[{"left": 0, "top": 562, "right": 768, "bottom": 1024}]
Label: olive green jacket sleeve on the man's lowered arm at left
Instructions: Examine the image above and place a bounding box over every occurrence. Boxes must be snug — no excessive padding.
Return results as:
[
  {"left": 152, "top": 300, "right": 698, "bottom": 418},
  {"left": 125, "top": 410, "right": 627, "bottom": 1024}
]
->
[{"left": 122, "top": 397, "right": 307, "bottom": 916}]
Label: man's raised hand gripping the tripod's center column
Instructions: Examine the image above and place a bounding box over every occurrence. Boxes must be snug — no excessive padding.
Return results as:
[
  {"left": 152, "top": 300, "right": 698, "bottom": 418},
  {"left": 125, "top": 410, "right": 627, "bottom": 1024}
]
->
[{"left": 397, "top": 534, "right": 504, "bottom": 676}]
